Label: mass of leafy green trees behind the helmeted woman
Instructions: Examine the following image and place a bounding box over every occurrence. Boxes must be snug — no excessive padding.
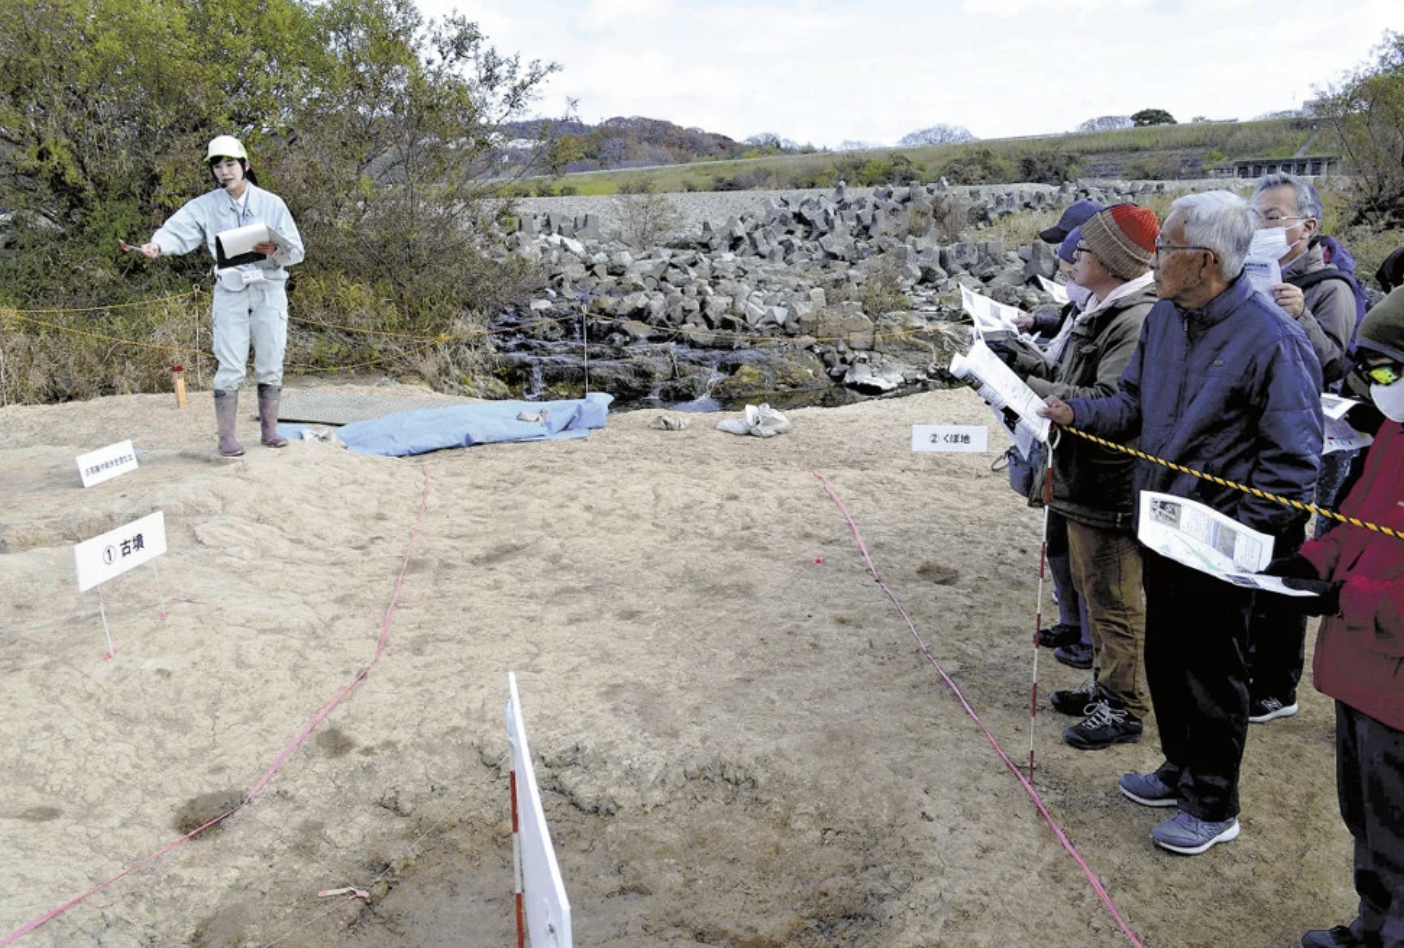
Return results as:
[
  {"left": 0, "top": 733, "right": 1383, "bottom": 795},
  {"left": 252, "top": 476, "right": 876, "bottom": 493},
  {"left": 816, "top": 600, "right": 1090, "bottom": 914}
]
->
[{"left": 0, "top": 0, "right": 556, "bottom": 310}]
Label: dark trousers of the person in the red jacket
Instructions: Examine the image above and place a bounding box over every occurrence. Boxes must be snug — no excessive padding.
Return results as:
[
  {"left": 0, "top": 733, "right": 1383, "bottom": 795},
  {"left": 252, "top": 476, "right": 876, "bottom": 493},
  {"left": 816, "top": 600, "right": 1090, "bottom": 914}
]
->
[{"left": 1335, "top": 701, "right": 1404, "bottom": 948}]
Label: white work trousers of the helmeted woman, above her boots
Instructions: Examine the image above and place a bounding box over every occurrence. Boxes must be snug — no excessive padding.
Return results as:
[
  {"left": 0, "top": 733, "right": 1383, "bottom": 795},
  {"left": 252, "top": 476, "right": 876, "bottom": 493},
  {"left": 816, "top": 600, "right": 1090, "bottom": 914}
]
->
[{"left": 215, "top": 279, "right": 288, "bottom": 392}]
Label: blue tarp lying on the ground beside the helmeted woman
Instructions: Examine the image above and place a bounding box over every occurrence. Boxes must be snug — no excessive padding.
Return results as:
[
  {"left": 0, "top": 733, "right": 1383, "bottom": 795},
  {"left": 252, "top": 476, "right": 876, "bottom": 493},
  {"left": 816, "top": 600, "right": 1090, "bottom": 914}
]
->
[{"left": 337, "top": 392, "right": 614, "bottom": 458}]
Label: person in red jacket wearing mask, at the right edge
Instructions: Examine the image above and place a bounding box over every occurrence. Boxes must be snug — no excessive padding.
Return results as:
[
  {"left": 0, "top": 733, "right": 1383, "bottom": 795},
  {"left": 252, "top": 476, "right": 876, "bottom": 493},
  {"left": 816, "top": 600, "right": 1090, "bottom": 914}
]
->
[{"left": 1265, "top": 288, "right": 1404, "bottom": 948}]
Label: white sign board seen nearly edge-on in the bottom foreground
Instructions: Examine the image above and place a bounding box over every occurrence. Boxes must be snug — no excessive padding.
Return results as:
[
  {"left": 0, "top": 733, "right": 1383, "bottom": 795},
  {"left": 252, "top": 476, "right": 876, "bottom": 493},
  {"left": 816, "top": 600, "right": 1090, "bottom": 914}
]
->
[{"left": 507, "top": 671, "right": 571, "bottom": 948}]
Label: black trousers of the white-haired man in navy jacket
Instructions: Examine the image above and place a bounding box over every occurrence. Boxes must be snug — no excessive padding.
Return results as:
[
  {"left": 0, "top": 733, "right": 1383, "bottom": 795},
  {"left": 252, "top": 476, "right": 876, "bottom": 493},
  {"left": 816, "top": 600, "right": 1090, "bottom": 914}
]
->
[{"left": 1141, "top": 549, "right": 1252, "bottom": 822}]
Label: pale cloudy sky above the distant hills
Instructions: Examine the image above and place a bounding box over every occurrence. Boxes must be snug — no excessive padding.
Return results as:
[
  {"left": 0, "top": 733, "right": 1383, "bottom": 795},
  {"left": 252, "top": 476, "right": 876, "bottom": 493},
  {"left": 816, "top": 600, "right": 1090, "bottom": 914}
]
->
[{"left": 418, "top": 0, "right": 1401, "bottom": 147}]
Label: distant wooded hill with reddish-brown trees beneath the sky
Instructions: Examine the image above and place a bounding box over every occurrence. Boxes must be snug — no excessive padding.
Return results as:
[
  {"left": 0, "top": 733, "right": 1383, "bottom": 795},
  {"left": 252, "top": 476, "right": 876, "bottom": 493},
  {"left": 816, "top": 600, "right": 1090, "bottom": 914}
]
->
[{"left": 501, "top": 115, "right": 750, "bottom": 174}]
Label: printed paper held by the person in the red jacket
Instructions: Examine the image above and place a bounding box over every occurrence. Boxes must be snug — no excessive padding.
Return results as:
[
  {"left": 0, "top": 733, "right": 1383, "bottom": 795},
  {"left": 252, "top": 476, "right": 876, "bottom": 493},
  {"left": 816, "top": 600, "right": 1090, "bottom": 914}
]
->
[{"left": 1136, "top": 490, "right": 1311, "bottom": 595}]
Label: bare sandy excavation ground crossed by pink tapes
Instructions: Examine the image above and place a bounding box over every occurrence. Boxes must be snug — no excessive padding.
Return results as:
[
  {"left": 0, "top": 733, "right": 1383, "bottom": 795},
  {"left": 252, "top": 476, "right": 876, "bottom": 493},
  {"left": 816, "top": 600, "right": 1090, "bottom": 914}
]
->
[{"left": 0, "top": 383, "right": 1353, "bottom": 948}]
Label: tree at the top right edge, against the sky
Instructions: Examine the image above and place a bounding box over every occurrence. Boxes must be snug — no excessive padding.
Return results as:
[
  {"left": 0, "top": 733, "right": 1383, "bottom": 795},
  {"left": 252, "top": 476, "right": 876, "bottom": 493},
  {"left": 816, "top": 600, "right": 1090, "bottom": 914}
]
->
[{"left": 1318, "top": 32, "right": 1404, "bottom": 225}]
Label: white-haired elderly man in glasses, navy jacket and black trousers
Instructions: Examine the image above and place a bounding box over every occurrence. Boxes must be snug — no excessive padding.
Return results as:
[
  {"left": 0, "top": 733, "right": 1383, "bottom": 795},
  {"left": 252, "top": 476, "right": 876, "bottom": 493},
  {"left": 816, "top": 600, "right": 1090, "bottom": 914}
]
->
[{"left": 1043, "top": 191, "right": 1323, "bottom": 855}]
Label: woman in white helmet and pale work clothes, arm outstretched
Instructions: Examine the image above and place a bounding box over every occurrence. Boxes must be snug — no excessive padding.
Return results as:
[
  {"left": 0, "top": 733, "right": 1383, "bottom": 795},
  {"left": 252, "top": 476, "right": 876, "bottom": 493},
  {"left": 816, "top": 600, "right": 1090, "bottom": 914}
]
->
[{"left": 142, "top": 135, "right": 303, "bottom": 458}]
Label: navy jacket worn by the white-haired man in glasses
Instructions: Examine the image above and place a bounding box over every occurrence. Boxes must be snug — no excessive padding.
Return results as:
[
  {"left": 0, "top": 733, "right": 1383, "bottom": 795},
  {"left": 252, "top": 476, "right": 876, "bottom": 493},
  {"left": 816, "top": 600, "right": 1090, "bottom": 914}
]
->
[{"left": 1068, "top": 277, "right": 1323, "bottom": 534}]
